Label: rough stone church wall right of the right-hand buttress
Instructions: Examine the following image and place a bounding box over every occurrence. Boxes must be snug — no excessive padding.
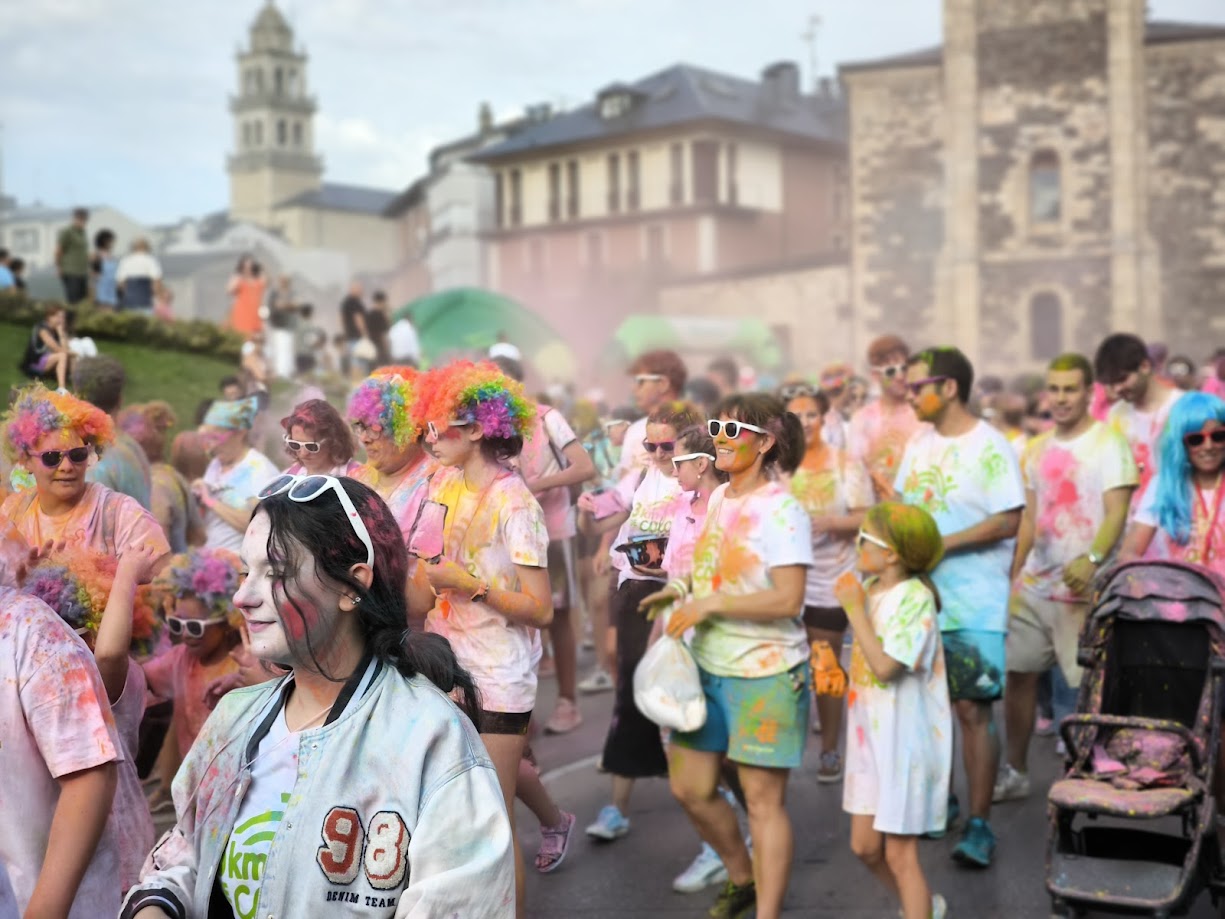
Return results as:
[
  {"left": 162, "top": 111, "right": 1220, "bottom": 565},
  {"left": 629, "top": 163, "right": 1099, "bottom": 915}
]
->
[{"left": 1147, "top": 40, "right": 1225, "bottom": 363}]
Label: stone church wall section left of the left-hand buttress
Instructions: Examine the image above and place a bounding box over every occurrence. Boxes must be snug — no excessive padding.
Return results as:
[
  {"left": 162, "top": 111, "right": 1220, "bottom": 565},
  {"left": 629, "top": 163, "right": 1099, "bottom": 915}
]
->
[{"left": 844, "top": 67, "right": 944, "bottom": 345}]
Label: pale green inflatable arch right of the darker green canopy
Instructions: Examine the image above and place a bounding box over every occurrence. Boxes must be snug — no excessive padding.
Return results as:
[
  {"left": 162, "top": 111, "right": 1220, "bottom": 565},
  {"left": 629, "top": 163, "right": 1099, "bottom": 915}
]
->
[{"left": 613, "top": 314, "right": 783, "bottom": 370}]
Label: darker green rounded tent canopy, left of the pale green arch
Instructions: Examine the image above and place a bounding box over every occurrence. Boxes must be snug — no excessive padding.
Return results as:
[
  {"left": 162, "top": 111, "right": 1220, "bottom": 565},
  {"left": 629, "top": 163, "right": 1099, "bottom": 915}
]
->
[{"left": 392, "top": 287, "right": 577, "bottom": 377}]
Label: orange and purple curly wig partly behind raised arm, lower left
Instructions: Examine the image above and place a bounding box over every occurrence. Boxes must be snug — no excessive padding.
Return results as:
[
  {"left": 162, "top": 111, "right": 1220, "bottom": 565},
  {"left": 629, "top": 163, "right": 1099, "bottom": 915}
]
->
[{"left": 21, "top": 550, "right": 160, "bottom": 654}]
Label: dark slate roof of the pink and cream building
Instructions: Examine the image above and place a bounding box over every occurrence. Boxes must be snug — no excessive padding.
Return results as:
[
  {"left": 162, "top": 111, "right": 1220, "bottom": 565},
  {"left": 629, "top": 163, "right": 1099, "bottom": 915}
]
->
[{"left": 470, "top": 64, "right": 845, "bottom": 162}]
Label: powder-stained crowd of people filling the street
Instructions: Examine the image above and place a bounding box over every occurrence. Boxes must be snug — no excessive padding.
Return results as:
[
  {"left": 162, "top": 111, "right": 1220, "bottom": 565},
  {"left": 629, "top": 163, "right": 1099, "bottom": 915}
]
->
[{"left": 0, "top": 321, "right": 1225, "bottom": 919}]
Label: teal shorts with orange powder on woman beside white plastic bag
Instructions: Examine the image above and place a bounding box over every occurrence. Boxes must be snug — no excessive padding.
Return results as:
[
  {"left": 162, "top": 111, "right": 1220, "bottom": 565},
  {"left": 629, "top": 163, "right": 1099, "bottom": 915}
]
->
[{"left": 670, "top": 660, "right": 809, "bottom": 770}]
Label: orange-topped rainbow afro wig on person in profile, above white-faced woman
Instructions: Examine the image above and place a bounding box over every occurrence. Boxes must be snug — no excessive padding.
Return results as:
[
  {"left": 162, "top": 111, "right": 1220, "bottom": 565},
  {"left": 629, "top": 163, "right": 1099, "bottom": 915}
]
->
[{"left": 418, "top": 360, "right": 537, "bottom": 440}]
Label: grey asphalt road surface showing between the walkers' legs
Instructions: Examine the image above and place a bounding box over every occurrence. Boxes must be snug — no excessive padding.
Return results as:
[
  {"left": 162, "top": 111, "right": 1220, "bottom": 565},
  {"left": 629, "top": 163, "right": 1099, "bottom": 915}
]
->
[{"left": 517, "top": 651, "right": 1218, "bottom": 919}]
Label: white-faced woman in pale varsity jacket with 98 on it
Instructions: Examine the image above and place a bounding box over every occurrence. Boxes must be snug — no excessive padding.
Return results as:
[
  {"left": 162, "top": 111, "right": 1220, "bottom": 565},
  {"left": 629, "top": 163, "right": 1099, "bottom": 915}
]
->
[{"left": 121, "top": 475, "right": 515, "bottom": 919}]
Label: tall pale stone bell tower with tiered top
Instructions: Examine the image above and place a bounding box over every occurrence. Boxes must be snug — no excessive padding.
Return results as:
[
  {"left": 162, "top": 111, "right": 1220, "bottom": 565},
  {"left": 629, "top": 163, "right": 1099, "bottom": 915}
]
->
[{"left": 228, "top": 0, "right": 323, "bottom": 227}]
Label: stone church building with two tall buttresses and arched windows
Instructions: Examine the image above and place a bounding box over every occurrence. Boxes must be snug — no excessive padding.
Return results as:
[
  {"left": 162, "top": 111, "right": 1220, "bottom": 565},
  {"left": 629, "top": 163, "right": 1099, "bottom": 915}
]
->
[{"left": 842, "top": 0, "right": 1225, "bottom": 373}]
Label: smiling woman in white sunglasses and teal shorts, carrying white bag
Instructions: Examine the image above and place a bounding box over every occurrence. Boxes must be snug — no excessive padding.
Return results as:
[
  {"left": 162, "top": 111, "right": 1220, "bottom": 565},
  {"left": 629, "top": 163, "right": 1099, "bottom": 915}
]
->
[{"left": 666, "top": 393, "right": 812, "bottom": 919}]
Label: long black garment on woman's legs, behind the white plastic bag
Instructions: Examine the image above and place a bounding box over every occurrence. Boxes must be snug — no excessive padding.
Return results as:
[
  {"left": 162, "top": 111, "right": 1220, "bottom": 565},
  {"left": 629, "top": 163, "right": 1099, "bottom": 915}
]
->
[{"left": 600, "top": 581, "right": 668, "bottom": 778}]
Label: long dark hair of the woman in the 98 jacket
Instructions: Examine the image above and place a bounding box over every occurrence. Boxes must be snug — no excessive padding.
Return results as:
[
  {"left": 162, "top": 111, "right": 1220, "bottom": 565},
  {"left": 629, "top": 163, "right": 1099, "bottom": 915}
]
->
[{"left": 255, "top": 478, "right": 480, "bottom": 728}]
